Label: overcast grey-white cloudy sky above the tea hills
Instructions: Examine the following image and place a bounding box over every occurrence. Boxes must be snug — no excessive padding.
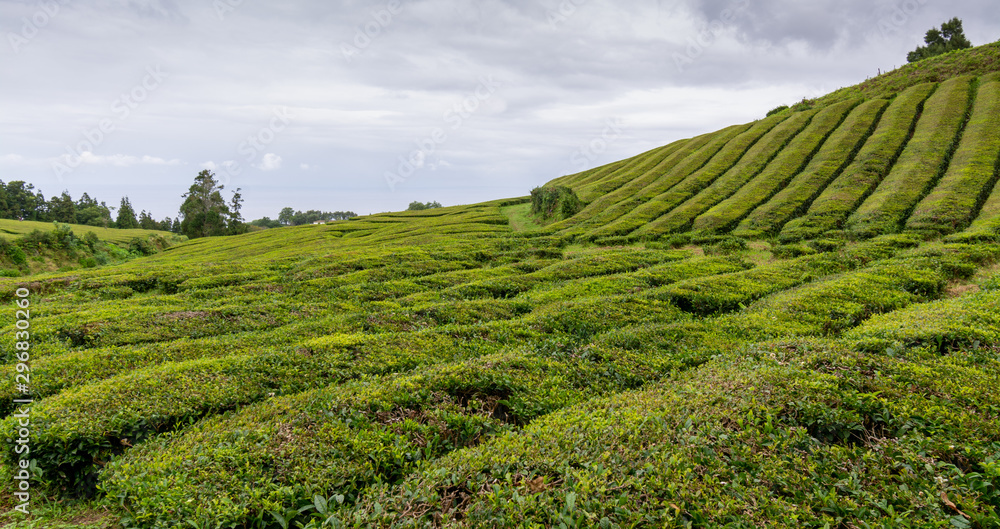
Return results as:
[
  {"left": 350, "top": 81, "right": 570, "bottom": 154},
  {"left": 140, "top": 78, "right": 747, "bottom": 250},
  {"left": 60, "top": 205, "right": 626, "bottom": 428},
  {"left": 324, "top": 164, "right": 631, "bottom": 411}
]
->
[{"left": 0, "top": 0, "right": 1000, "bottom": 219}]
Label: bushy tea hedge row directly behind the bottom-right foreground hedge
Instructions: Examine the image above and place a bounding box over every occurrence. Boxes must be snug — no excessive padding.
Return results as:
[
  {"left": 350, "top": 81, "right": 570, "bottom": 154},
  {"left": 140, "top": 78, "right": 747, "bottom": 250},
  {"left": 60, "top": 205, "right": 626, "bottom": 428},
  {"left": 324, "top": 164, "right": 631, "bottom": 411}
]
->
[{"left": 102, "top": 340, "right": 704, "bottom": 528}]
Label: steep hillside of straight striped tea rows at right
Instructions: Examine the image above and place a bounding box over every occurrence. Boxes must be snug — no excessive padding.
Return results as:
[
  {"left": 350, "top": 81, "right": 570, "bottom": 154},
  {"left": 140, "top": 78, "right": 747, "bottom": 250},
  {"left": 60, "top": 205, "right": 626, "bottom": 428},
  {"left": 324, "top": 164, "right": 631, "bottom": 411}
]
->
[{"left": 547, "top": 44, "right": 1000, "bottom": 243}]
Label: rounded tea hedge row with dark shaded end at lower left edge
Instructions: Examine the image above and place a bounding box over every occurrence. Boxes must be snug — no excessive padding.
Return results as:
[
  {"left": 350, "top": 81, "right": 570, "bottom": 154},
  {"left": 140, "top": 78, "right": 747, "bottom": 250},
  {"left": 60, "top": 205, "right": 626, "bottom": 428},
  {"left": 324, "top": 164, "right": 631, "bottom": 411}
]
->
[{"left": 0, "top": 333, "right": 494, "bottom": 493}]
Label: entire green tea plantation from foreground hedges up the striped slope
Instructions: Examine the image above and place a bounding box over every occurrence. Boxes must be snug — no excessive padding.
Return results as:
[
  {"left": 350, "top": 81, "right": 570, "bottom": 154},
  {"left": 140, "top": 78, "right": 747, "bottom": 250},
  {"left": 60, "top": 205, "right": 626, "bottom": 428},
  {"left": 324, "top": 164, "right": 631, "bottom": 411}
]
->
[{"left": 0, "top": 44, "right": 1000, "bottom": 529}]
